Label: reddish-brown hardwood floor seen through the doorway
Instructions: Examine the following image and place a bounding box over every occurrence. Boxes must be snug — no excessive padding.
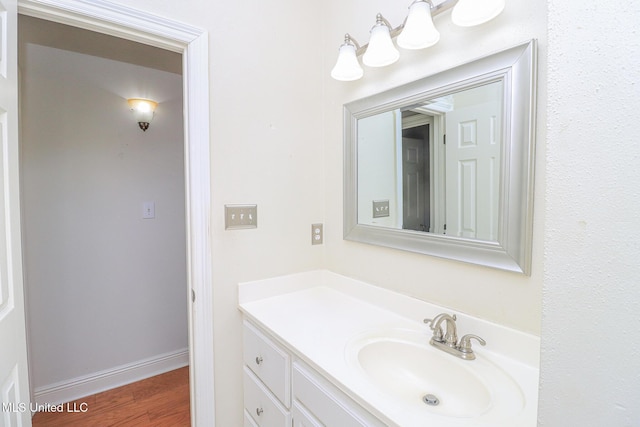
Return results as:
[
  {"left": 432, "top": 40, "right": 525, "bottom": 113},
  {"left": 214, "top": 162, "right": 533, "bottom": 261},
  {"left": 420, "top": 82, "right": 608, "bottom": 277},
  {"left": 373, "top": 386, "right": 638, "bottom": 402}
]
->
[{"left": 33, "top": 367, "right": 190, "bottom": 427}]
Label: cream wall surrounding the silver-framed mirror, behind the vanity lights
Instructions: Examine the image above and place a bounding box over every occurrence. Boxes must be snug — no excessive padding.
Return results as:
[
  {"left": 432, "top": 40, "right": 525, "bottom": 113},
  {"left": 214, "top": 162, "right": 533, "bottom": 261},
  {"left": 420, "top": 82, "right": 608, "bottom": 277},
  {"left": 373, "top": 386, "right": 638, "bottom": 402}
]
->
[{"left": 322, "top": 0, "right": 547, "bottom": 334}]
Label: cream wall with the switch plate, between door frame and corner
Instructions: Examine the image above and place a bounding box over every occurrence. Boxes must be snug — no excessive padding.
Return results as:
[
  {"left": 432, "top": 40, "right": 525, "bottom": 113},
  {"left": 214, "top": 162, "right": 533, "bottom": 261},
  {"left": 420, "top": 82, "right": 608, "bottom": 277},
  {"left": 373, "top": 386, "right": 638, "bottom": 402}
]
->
[{"left": 110, "top": 0, "right": 328, "bottom": 426}]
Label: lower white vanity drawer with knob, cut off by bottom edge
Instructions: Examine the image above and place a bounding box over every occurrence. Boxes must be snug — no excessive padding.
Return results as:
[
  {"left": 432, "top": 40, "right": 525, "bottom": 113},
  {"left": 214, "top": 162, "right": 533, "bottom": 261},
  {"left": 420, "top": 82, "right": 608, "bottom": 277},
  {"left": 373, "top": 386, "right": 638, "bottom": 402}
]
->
[{"left": 243, "top": 366, "right": 291, "bottom": 427}]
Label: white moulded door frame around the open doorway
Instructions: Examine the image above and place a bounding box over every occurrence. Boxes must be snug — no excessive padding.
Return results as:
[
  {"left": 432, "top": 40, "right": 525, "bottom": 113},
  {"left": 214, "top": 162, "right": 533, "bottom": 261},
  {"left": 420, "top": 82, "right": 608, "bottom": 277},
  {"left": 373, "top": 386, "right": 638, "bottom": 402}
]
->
[{"left": 18, "top": 0, "right": 215, "bottom": 426}]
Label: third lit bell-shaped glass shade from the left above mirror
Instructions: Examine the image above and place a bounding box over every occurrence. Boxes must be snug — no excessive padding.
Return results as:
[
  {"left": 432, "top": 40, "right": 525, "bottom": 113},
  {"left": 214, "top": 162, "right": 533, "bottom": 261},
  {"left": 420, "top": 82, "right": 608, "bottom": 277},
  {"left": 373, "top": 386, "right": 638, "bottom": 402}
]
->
[{"left": 398, "top": 0, "right": 440, "bottom": 49}]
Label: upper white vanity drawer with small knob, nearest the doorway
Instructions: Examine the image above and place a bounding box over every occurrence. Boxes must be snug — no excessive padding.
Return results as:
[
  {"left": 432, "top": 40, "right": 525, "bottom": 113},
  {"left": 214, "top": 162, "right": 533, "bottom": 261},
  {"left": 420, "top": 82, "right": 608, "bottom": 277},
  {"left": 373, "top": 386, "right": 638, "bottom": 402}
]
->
[{"left": 243, "top": 321, "right": 291, "bottom": 408}]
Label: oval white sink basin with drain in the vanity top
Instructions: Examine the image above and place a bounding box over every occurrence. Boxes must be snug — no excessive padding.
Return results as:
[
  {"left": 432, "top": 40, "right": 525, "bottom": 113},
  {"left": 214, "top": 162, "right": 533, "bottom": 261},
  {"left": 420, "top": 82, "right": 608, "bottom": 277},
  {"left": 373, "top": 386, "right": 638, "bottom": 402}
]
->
[{"left": 346, "top": 329, "right": 525, "bottom": 421}]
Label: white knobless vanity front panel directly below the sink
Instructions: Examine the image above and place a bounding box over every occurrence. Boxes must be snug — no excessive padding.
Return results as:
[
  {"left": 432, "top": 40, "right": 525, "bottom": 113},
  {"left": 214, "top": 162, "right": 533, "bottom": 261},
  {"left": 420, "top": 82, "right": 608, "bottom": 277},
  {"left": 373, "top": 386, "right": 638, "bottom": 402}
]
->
[{"left": 292, "top": 362, "right": 386, "bottom": 427}]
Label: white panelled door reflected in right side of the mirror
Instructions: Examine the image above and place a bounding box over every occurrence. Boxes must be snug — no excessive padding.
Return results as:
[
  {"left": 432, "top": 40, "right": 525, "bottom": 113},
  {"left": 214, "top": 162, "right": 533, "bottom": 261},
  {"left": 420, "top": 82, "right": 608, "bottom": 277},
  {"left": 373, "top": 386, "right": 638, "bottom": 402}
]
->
[{"left": 446, "top": 102, "right": 502, "bottom": 241}]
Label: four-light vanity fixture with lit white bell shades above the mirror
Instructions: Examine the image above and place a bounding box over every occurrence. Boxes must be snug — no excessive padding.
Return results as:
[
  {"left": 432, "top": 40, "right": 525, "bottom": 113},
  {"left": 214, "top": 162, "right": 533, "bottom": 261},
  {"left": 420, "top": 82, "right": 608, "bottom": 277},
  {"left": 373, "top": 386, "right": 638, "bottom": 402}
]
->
[{"left": 331, "top": 0, "right": 505, "bottom": 81}]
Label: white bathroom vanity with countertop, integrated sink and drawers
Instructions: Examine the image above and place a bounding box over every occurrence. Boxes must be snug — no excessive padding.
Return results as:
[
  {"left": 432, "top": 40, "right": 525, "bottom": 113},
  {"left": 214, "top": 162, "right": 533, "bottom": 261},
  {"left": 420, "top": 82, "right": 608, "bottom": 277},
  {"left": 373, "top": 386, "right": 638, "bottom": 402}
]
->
[{"left": 239, "top": 270, "right": 539, "bottom": 427}]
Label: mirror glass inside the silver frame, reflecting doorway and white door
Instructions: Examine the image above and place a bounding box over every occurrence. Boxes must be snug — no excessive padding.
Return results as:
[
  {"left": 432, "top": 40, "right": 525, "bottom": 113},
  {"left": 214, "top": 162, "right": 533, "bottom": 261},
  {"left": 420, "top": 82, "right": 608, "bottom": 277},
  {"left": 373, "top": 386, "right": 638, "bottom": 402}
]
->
[{"left": 357, "top": 80, "right": 504, "bottom": 241}]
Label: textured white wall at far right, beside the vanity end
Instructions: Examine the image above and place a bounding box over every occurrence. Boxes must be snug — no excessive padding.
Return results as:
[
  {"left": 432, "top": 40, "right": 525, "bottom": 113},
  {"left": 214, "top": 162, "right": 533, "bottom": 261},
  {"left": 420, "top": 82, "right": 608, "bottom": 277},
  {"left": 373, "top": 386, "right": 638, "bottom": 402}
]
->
[{"left": 539, "top": 0, "right": 640, "bottom": 427}]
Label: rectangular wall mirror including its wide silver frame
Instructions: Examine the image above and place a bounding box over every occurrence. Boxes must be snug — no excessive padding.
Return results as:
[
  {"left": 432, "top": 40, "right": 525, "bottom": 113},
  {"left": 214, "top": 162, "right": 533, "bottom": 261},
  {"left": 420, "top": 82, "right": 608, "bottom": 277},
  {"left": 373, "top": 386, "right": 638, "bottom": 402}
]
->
[{"left": 344, "top": 41, "right": 536, "bottom": 274}]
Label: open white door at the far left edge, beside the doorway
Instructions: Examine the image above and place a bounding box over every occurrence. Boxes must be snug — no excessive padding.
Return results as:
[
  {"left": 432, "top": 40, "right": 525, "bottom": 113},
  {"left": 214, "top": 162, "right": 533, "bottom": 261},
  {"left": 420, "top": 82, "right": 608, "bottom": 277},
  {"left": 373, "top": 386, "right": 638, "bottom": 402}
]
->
[{"left": 0, "top": 0, "right": 31, "bottom": 427}]
